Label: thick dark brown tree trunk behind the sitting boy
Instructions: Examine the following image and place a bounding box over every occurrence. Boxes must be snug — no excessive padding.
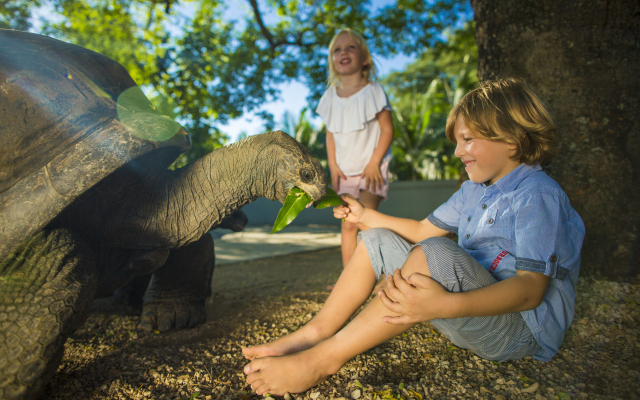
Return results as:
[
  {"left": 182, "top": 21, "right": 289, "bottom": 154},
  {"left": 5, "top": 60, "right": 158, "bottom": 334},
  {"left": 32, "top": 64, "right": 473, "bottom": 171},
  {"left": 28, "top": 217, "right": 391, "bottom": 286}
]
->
[{"left": 471, "top": 0, "right": 640, "bottom": 281}]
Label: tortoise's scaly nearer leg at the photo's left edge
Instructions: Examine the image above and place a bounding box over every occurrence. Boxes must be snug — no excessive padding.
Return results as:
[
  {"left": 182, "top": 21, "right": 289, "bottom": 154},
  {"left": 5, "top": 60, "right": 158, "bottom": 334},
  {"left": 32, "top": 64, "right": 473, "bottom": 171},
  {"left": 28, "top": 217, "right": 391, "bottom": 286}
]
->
[{"left": 0, "top": 229, "right": 97, "bottom": 400}]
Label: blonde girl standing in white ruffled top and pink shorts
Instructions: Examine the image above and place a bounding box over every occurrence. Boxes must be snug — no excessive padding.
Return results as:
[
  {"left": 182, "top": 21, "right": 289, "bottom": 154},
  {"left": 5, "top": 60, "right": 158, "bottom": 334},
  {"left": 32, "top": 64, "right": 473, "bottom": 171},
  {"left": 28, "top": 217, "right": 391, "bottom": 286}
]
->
[{"left": 316, "top": 28, "right": 393, "bottom": 276}]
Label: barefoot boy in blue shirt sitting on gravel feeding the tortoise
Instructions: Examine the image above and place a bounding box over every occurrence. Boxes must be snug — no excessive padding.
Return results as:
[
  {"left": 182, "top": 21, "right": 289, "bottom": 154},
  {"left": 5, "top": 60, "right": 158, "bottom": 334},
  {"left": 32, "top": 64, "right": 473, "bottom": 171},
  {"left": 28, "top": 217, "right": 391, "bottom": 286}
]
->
[{"left": 243, "top": 79, "right": 584, "bottom": 395}]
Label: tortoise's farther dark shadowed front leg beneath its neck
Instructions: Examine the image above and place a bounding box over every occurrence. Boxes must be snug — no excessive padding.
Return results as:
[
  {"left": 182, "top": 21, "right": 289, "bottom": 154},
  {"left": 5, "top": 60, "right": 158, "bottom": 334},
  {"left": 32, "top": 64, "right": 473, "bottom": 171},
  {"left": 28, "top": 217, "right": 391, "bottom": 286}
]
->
[{"left": 140, "top": 234, "right": 215, "bottom": 331}]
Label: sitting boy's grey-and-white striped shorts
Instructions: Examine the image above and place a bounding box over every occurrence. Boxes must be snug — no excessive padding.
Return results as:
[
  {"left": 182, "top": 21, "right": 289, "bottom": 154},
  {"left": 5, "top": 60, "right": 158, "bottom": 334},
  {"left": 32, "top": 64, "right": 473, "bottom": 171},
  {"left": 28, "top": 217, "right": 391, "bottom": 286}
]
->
[{"left": 358, "top": 228, "right": 540, "bottom": 361}]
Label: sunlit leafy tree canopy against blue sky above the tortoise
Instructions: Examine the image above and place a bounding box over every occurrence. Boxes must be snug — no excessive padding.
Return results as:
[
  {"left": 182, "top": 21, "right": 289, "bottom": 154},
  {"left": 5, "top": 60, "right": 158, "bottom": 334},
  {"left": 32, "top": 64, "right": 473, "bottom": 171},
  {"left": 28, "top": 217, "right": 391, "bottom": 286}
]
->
[{"left": 0, "top": 0, "right": 471, "bottom": 166}]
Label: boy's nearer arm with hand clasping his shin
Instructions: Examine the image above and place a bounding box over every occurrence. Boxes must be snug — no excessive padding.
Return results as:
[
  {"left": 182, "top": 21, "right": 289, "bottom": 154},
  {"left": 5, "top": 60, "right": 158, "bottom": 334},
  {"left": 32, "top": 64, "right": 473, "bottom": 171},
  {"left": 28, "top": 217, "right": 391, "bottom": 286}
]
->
[{"left": 378, "top": 270, "right": 550, "bottom": 324}]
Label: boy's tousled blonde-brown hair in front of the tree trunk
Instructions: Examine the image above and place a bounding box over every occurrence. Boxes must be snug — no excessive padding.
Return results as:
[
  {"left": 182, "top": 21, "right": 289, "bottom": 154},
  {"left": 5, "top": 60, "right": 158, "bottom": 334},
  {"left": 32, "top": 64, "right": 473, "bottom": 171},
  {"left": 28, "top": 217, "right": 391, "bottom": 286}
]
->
[{"left": 446, "top": 78, "right": 557, "bottom": 166}]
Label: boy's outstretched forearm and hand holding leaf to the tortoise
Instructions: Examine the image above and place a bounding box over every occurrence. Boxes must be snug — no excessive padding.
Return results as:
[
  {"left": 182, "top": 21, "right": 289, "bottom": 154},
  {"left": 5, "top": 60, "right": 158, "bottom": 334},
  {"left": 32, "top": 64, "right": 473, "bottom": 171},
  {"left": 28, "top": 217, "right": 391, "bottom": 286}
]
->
[{"left": 333, "top": 195, "right": 449, "bottom": 243}]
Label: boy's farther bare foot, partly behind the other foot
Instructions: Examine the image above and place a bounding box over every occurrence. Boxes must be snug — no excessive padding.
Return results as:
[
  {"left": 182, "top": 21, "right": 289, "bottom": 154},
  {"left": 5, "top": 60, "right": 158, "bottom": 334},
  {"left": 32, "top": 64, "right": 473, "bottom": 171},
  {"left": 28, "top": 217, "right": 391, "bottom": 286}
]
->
[{"left": 242, "top": 324, "right": 328, "bottom": 360}]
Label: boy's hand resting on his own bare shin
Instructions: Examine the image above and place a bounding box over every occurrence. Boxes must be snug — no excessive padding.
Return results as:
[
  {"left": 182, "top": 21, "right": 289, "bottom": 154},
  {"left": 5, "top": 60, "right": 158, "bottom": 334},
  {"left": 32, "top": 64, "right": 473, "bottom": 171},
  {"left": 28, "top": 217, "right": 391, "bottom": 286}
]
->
[{"left": 378, "top": 269, "right": 454, "bottom": 325}]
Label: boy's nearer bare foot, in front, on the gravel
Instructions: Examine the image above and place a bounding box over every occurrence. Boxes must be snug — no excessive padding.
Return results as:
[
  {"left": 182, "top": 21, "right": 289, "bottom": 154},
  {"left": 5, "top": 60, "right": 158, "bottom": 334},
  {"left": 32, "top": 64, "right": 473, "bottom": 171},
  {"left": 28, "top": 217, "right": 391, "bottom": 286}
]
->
[{"left": 244, "top": 349, "right": 340, "bottom": 396}]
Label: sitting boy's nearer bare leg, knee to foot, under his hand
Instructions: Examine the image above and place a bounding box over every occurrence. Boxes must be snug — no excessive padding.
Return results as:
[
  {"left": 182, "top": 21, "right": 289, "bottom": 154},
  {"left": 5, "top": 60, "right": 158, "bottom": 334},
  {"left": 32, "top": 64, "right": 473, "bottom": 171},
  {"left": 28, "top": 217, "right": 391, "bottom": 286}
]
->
[{"left": 244, "top": 247, "right": 429, "bottom": 396}]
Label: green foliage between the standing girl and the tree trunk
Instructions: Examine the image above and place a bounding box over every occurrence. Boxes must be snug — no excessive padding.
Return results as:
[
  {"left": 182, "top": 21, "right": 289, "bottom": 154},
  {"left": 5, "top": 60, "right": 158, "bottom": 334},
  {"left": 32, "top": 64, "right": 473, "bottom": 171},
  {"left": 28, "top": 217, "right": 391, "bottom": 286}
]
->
[{"left": 383, "top": 22, "right": 477, "bottom": 180}]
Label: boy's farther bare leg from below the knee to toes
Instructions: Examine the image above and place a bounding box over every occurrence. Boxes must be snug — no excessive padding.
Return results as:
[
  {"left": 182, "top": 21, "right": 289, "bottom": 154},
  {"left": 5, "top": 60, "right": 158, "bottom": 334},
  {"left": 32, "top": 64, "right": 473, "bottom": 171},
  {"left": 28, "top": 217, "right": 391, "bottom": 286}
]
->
[{"left": 242, "top": 241, "right": 376, "bottom": 359}]
